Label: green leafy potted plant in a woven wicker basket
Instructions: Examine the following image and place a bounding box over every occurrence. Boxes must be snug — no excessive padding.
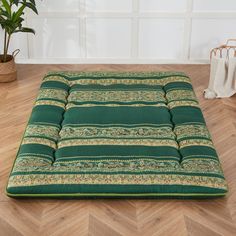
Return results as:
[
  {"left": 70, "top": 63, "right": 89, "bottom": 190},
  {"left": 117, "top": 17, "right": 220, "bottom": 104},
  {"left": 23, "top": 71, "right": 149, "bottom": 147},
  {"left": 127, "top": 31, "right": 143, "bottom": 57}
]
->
[{"left": 0, "top": 0, "right": 38, "bottom": 82}]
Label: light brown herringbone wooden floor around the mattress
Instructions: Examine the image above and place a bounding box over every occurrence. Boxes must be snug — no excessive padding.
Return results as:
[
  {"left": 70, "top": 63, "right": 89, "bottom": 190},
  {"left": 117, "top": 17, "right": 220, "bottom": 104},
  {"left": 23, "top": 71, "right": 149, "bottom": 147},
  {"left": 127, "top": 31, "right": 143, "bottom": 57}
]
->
[{"left": 0, "top": 65, "right": 236, "bottom": 236}]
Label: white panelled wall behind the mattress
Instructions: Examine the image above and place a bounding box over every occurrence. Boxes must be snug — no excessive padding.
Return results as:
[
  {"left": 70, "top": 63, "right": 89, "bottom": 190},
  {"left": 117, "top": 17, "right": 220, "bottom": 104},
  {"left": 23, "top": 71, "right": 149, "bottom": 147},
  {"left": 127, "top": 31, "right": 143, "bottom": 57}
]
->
[{"left": 3, "top": 0, "right": 236, "bottom": 63}]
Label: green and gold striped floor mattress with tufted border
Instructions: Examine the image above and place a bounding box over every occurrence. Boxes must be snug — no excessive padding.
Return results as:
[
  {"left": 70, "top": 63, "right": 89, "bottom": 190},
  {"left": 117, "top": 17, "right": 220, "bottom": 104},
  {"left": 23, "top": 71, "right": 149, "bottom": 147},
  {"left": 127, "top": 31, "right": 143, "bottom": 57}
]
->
[{"left": 6, "top": 72, "right": 227, "bottom": 198}]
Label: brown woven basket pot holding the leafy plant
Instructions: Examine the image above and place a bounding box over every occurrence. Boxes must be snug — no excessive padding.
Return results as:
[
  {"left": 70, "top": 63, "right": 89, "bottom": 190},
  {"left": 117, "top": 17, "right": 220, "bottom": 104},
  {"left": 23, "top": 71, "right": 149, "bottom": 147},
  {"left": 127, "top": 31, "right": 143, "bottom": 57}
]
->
[{"left": 0, "top": 55, "right": 17, "bottom": 83}]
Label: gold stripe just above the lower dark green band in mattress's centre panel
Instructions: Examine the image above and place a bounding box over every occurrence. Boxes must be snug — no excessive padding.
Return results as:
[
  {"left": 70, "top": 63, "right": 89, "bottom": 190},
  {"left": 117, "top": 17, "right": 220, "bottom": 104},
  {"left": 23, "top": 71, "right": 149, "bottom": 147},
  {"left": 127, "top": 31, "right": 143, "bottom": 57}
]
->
[{"left": 58, "top": 139, "right": 178, "bottom": 148}]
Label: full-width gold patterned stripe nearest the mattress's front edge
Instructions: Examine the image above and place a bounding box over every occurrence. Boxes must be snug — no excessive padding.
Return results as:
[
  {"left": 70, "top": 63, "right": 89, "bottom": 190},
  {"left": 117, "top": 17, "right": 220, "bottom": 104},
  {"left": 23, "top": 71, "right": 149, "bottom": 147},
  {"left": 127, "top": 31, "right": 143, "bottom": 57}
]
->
[{"left": 8, "top": 174, "right": 227, "bottom": 190}]
